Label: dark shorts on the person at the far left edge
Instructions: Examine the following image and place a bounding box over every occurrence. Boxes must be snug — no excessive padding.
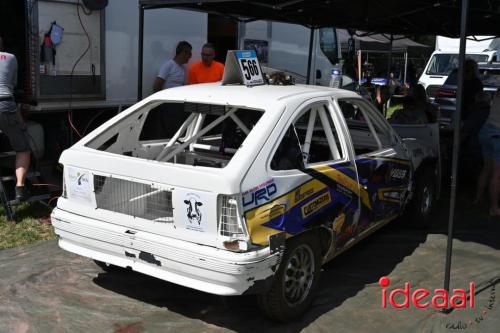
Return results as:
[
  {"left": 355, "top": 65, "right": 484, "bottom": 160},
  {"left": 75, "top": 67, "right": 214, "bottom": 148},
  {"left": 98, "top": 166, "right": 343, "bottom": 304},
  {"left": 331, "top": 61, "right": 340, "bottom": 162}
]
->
[{"left": 0, "top": 111, "right": 31, "bottom": 153}]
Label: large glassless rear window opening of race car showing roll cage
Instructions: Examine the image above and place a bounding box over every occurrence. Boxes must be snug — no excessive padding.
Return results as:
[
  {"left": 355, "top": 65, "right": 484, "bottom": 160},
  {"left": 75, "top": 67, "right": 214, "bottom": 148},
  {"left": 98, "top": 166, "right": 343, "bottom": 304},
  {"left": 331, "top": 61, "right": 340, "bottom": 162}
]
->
[{"left": 87, "top": 102, "right": 263, "bottom": 168}]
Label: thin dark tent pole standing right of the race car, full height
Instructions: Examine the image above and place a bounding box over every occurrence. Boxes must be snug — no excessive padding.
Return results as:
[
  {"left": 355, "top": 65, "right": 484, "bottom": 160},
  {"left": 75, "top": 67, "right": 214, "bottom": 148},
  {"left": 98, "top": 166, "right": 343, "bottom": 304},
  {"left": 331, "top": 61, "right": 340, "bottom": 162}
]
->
[{"left": 444, "top": 0, "right": 469, "bottom": 300}]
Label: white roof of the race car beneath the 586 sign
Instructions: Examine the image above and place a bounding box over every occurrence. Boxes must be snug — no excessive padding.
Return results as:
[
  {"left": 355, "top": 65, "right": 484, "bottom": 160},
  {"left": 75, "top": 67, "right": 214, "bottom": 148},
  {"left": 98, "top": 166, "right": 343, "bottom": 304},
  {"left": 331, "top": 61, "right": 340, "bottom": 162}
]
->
[{"left": 148, "top": 82, "right": 359, "bottom": 109}]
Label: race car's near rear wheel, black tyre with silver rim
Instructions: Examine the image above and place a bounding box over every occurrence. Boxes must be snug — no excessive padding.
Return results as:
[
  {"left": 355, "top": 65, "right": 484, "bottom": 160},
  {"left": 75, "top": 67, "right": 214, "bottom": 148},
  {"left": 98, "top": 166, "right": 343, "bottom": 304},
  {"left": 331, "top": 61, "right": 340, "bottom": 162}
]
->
[{"left": 257, "top": 233, "right": 321, "bottom": 322}]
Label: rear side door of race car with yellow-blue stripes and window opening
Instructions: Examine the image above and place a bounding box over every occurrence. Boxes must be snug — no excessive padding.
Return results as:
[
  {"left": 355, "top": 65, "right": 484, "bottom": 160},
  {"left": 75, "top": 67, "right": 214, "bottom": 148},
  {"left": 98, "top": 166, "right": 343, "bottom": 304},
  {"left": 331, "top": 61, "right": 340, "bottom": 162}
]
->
[{"left": 266, "top": 99, "right": 359, "bottom": 252}]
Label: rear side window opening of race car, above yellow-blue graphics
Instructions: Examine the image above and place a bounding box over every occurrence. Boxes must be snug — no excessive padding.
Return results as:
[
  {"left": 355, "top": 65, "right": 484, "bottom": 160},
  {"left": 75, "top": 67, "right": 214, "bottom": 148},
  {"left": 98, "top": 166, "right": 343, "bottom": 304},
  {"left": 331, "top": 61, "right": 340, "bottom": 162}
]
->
[{"left": 271, "top": 105, "right": 344, "bottom": 170}]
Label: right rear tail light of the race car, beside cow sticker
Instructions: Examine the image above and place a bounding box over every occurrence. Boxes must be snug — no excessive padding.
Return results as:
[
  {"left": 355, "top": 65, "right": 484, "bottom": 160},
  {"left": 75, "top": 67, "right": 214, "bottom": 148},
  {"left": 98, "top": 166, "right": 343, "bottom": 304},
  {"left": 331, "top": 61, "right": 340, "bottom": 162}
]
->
[{"left": 218, "top": 195, "right": 248, "bottom": 251}]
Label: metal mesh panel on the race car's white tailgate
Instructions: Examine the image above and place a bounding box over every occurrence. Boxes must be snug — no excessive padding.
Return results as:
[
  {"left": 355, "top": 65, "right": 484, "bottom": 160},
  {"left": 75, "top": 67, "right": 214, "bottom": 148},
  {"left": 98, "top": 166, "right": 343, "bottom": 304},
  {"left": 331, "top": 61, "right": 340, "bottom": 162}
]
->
[{"left": 94, "top": 175, "right": 173, "bottom": 222}]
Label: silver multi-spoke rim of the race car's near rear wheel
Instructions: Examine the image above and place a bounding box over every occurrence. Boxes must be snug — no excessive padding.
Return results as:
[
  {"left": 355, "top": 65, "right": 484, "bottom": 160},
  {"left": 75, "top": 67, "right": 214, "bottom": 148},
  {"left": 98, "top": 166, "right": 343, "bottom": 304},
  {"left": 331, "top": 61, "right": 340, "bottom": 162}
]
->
[{"left": 283, "top": 245, "right": 315, "bottom": 306}]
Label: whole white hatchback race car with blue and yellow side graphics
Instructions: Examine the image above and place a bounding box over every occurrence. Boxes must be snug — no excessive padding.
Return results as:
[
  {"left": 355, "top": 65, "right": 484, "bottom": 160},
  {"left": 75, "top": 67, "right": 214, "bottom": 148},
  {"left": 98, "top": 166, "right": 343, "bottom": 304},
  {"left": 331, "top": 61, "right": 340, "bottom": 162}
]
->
[{"left": 52, "top": 83, "right": 439, "bottom": 321}]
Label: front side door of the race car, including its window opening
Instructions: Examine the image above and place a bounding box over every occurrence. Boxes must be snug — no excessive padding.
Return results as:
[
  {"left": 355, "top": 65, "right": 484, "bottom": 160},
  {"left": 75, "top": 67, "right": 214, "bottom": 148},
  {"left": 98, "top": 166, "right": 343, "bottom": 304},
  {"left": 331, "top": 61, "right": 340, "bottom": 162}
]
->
[{"left": 336, "top": 98, "right": 412, "bottom": 231}]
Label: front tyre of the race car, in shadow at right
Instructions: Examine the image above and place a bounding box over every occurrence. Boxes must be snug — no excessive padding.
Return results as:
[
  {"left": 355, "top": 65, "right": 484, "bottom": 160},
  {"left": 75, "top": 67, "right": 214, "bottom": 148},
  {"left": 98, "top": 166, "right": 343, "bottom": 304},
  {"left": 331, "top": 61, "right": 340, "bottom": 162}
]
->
[{"left": 409, "top": 167, "right": 436, "bottom": 228}]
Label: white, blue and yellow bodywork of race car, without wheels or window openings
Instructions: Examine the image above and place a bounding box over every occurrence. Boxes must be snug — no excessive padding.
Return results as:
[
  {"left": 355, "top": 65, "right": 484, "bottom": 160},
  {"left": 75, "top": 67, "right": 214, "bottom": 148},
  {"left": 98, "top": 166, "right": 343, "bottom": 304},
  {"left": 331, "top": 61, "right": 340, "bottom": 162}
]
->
[{"left": 52, "top": 83, "right": 434, "bottom": 295}]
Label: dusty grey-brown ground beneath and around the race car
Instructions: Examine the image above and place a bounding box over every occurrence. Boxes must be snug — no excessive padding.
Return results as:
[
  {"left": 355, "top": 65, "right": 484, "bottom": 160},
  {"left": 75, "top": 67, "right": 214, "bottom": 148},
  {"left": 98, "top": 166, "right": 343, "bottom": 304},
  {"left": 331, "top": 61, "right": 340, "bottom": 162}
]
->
[{"left": 0, "top": 193, "right": 500, "bottom": 333}]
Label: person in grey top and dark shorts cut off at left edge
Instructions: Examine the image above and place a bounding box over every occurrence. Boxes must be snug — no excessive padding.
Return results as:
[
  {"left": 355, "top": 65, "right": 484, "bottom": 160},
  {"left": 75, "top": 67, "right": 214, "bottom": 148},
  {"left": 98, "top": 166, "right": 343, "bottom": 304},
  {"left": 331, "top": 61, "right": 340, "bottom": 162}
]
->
[{"left": 0, "top": 37, "right": 31, "bottom": 201}]
